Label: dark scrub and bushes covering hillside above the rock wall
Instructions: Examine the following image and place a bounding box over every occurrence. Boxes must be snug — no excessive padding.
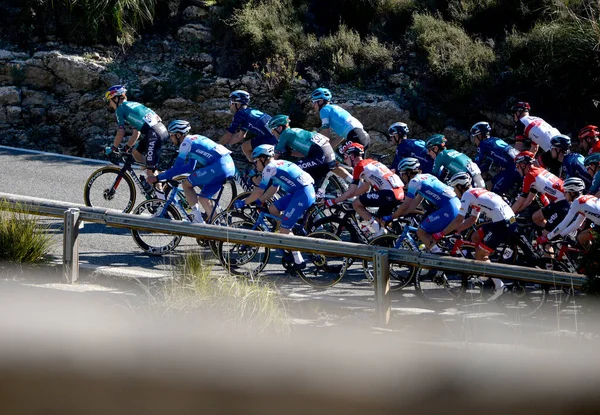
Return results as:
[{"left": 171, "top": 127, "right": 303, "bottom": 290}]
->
[{"left": 0, "top": 0, "right": 600, "bottom": 126}]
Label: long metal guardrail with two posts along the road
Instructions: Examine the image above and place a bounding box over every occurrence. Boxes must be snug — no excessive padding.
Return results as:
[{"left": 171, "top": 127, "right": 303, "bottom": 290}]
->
[{"left": 0, "top": 192, "right": 585, "bottom": 324}]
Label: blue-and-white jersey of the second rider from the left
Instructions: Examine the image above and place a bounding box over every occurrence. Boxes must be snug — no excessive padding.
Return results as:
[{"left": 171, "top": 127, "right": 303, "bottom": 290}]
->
[{"left": 157, "top": 135, "right": 231, "bottom": 180}]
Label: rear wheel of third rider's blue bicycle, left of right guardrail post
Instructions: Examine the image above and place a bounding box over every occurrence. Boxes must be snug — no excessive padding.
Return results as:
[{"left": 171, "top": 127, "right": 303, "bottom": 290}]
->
[{"left": 296, "top": 231, "right": 349, "bottom": 288}]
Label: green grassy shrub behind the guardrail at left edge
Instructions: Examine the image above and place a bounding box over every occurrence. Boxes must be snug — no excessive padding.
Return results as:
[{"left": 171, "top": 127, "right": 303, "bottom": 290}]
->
[{"left": 0, "top": 203, "right": 52, "bottom": 263}]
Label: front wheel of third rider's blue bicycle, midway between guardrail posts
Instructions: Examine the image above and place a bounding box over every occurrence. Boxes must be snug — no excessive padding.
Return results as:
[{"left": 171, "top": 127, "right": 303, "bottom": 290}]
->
[{"left": 217, "top": 221, "right": 270, "bottom": 279}]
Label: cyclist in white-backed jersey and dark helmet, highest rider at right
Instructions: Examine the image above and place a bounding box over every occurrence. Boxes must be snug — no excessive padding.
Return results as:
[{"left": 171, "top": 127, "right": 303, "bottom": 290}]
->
[{"left": 511, "top": 101, "right": 560, "bottom": 167}]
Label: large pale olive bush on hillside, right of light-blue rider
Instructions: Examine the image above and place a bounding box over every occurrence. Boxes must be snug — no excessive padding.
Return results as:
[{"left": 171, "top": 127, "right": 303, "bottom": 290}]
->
[{"left": 411, "top": 14, "right": 496, "bottom": 99}]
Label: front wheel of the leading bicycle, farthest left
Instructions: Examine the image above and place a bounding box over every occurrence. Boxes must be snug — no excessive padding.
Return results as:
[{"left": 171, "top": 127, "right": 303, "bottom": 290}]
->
[{"left": 83, "top": 166, "right": 137, "bottom": 213}]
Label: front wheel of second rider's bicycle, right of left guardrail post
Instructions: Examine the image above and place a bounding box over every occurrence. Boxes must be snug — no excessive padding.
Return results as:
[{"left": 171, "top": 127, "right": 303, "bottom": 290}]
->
[{"left": 131, "top": 199, "right": 182, "bottom": 256}]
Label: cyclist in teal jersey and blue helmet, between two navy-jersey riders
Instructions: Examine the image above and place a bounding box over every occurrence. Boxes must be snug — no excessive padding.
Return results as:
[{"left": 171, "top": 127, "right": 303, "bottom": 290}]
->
[{"left": 425, "top": 134, "right": 485, "bottom": 188}]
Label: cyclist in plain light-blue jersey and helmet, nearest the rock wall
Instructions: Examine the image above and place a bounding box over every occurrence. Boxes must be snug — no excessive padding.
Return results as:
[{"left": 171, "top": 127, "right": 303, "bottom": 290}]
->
[{"left": 310, "top": 88, "right": 371, "bottom": 151}]
